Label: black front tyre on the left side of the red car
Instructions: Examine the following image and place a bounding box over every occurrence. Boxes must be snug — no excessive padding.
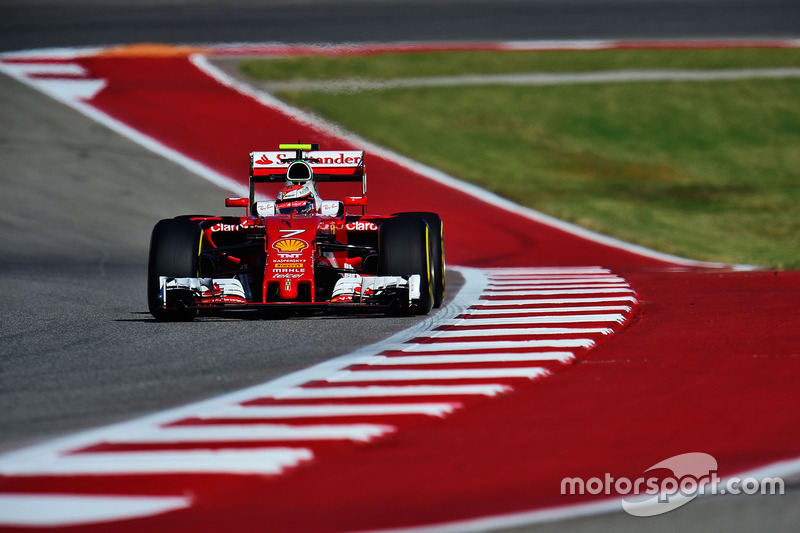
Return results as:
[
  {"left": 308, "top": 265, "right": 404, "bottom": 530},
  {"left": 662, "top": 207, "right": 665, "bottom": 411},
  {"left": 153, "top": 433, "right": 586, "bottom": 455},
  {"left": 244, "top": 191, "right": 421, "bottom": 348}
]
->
[{"left": 147, "top": 217, "right": 202, "bottom": 322}]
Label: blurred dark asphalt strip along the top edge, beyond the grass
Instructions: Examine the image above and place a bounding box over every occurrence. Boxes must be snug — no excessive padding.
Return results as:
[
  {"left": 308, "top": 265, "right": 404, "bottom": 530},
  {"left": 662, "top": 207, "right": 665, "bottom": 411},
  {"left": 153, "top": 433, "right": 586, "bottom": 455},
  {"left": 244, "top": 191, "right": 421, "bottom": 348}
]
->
[{"left": 0, "top": 0, "right": 800, "bottom": 50}]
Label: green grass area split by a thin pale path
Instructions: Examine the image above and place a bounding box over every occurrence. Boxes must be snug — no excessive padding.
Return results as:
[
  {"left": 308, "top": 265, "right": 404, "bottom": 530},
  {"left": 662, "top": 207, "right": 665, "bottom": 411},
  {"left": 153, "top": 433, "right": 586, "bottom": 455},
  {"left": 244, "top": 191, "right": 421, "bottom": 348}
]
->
[{"left": 241, "top": 49, "right": 800, "bottom": 269}]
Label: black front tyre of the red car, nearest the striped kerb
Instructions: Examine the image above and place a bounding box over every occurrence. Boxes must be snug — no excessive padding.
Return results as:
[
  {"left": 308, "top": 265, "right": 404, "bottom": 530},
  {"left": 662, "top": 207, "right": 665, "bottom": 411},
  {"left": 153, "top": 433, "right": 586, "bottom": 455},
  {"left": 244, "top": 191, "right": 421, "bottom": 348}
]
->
[{"left": 378, "top": 215, "right": 433, "bottom": 315}]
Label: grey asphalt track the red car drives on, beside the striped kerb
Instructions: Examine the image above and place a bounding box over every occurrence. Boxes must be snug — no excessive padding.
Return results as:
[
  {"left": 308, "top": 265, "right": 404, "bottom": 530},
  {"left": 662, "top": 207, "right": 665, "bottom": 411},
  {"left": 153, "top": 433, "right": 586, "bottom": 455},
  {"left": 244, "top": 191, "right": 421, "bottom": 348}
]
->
[{"left": 0, "top": 1, "right": 791, "bottom": 530}]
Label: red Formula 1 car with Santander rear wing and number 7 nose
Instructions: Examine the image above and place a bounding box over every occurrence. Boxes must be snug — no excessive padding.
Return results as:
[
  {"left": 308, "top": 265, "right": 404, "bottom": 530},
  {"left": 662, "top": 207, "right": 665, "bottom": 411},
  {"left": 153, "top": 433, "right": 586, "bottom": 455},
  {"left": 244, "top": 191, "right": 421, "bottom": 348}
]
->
[{"left": 147, "top": 144, "right": 445, "bottom": 320}]
